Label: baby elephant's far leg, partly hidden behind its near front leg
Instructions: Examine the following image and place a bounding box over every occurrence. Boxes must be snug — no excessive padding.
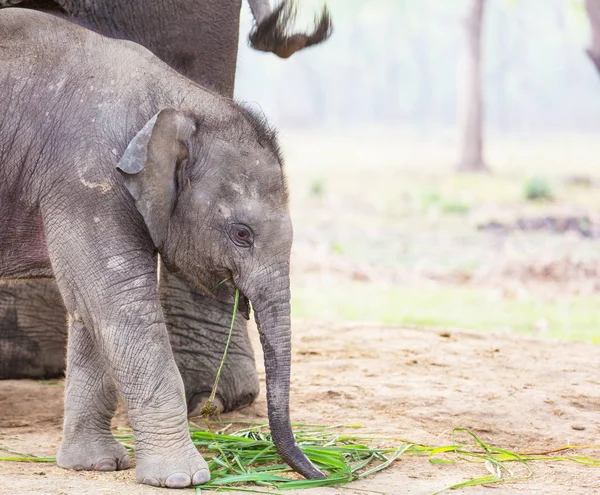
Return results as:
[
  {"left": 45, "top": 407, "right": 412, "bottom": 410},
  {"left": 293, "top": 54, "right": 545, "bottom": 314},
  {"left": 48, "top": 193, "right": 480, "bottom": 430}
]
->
[{"left": 57, "top": 318, "right": 130, "bottom": 471}]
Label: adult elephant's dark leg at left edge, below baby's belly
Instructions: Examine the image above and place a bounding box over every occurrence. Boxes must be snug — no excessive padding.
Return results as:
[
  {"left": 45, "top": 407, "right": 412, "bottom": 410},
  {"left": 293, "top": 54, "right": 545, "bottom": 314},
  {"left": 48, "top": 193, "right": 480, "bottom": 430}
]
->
[{"left": 0, "top": 280, "right": 67, "bottom": 379}]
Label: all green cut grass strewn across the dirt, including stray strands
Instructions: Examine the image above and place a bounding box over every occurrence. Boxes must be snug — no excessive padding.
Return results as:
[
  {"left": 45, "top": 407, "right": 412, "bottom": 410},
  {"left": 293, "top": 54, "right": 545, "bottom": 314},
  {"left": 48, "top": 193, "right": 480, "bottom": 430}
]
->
[{"left": 0, "top": 422, "right": 600, "bottom": 495}]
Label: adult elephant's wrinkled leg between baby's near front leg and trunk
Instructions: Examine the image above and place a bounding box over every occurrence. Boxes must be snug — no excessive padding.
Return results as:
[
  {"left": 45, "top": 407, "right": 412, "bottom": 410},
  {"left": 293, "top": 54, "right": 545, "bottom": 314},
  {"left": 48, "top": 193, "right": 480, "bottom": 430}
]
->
[{"left": 159, "top": 265, "right": 259, "bottom": 416}]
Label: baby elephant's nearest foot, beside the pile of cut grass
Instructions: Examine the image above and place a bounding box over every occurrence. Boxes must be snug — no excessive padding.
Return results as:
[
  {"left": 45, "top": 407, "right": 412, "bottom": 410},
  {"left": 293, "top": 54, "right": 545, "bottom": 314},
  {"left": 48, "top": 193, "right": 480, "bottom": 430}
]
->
[{"left": 135, "top": 448, "right": 210, "bottom": 488}]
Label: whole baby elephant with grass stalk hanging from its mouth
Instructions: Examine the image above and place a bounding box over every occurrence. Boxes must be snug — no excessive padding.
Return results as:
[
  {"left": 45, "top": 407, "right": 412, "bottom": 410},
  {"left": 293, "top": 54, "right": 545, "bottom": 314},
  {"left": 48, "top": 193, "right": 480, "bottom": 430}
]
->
[{"left": 0, "top": 9, "right": 324, "bottom": 488}]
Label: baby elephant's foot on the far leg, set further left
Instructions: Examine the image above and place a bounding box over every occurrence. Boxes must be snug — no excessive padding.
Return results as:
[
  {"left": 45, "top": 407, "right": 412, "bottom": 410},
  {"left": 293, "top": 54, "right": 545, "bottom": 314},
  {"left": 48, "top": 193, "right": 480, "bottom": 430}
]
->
[{"left": 56, "top": 437, "right": 131, "bottom": 471}]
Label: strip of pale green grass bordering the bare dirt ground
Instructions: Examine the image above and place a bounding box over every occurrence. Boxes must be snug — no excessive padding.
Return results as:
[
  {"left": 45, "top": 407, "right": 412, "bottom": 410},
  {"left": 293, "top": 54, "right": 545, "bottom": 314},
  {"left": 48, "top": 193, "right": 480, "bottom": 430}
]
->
[{"left": 292, "top": 282, "right": 600, "bottom": 343}]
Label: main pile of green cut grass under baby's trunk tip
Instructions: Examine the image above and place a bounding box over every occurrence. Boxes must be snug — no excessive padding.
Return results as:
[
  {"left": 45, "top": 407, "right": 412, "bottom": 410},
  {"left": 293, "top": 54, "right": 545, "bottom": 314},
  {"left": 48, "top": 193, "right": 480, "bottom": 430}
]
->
[{"left": 116, "top": 422, "right": 408, "bottom": 490}]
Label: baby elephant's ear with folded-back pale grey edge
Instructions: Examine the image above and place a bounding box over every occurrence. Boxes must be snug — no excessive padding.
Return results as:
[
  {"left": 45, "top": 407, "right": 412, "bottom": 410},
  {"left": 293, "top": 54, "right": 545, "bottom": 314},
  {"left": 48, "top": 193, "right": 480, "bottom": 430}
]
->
[{"left": 117, "top": 108, "right": 196, "bottom": 248}]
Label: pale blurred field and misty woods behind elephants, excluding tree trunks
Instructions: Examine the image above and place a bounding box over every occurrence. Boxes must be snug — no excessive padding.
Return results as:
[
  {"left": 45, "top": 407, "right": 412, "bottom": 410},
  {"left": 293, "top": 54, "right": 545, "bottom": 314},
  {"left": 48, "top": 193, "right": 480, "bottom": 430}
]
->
[{"left": 237, "top": 0, "right": 600, "bottom": 342}]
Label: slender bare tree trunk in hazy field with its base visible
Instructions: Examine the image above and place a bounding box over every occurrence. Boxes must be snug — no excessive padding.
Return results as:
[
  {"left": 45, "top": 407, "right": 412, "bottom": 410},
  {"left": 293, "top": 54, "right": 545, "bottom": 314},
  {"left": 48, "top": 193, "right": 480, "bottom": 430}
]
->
[{"left": 458, "top": 0, "right": 487, "bottom": 172}]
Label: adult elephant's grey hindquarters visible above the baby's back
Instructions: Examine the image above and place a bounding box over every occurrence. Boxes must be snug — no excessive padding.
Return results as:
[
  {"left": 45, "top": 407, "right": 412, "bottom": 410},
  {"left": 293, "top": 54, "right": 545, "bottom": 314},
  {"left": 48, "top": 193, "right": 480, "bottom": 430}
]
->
[{"left": 39, "top": 0, "right": 242, "bottom": 96}]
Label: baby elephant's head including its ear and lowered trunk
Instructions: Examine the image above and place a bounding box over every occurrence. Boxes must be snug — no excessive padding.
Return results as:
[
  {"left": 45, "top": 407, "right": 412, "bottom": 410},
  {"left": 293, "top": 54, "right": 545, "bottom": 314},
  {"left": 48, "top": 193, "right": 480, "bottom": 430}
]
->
[{"left": 118, "top": 106, "right": 323, "bottom": 478}]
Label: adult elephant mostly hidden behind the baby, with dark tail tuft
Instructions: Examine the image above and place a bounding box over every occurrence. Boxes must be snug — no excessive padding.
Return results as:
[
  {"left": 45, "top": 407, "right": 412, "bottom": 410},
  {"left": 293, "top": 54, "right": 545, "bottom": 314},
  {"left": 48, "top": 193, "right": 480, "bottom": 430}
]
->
[{"left": 0, "top": 0, "right": 331, "bottom": 415}]
